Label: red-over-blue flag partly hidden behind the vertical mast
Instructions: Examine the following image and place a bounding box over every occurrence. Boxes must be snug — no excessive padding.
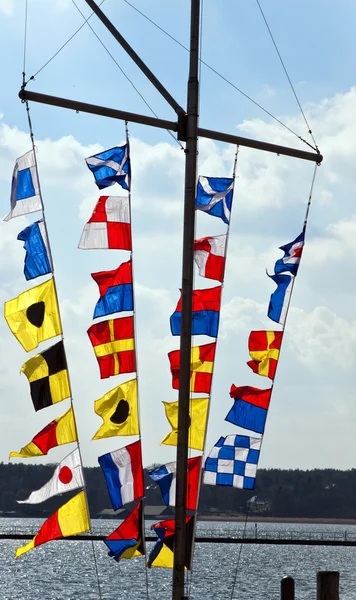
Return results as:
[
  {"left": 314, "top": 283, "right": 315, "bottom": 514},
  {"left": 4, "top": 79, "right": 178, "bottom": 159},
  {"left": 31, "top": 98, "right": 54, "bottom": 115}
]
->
[{"left": 171, "top": 285, "right": 221, "bottom": 337}]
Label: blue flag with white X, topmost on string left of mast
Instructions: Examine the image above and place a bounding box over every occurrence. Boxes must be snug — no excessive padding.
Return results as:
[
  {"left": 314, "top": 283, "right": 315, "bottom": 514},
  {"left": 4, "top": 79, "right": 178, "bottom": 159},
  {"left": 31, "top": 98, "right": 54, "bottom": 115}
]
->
[{"left": 85, "top": 144, "right": 130, "bottom": 190}]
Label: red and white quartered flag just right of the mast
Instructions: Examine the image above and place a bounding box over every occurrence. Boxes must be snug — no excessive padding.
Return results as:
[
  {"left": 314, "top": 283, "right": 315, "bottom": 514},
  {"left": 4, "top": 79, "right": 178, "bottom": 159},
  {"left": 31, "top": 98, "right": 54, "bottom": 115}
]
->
[{"left": 194, "top": 235, "right": 226, "bottom": 282}]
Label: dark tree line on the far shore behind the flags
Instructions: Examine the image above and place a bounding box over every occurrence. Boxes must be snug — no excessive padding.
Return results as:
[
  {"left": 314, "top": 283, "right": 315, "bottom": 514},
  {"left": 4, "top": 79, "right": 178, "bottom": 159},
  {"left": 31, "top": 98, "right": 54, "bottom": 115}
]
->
[{"left": 0, "top": 463, "right": 356, "bottom": 519}]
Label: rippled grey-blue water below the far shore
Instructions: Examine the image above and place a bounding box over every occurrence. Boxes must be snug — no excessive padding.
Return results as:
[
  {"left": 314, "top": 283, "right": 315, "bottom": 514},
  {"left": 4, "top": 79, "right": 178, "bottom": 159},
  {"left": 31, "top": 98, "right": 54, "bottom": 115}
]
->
[{"left": 0, "top": 519, "right": 356, "bottom": 600}]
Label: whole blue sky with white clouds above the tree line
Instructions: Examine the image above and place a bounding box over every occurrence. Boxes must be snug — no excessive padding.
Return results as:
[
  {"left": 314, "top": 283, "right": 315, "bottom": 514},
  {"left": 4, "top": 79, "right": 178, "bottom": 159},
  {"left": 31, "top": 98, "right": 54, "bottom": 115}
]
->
[{"left": 0, "top": 0, "right": 356, "bottom": 469}]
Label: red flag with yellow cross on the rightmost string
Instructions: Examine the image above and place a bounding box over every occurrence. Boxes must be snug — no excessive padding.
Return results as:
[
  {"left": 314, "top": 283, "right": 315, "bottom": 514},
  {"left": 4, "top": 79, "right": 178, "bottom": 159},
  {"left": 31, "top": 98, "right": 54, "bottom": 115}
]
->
[{"left": 247, "top": 331, "right": 283, "bottom": 379}]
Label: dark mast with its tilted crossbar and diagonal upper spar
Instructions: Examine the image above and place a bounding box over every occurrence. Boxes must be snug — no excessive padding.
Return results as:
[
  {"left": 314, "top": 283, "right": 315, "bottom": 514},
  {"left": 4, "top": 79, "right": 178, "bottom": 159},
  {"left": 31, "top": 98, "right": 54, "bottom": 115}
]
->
[{"left": 19, "top": 0, "right": 323, "bottom": 600}]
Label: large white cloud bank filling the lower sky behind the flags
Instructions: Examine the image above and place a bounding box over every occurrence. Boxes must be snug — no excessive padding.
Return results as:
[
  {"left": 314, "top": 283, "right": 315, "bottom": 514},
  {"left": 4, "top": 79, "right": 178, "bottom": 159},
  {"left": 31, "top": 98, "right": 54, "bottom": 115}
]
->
[{"left": 0, "top": 89, "right": 356, "bottom": 467}]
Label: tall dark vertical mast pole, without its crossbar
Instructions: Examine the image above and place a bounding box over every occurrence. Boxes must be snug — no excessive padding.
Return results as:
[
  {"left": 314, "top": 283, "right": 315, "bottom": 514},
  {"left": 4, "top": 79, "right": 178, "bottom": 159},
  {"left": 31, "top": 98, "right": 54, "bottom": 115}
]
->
[{"left": 172, "top": 0, "right": 200, "bottom": 600}]
